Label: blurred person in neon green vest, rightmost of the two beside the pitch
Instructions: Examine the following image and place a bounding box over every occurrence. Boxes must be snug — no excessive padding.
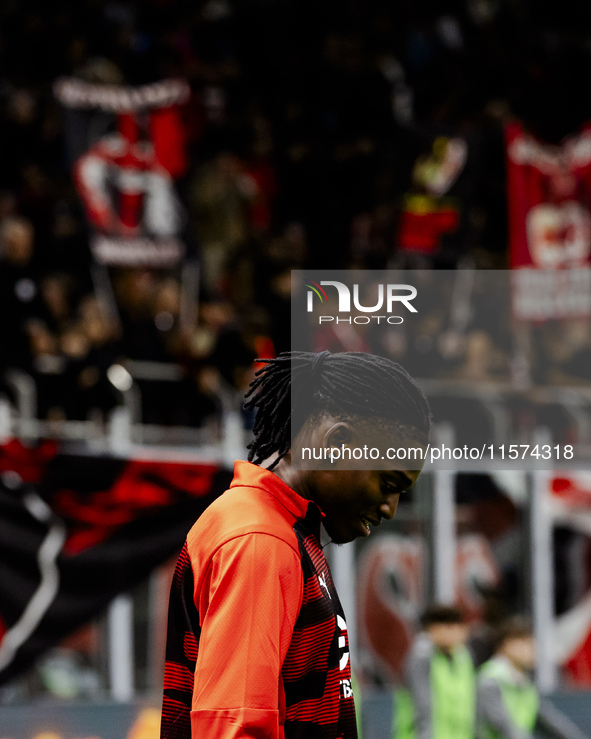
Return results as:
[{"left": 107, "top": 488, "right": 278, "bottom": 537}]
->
[{"left": 476, "top": 616, "right": 586, "bottom": 739}]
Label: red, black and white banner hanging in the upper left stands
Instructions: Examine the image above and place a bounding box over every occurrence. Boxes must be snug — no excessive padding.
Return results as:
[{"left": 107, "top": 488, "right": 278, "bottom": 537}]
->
[{"left": 54, "top": 79, "right": 190, "bottom": 267}]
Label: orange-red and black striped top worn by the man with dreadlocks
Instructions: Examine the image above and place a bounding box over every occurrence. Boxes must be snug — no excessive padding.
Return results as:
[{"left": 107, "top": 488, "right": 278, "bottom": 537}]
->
[{"left": 161, "top": 462, "right": 357, "bottom": 739}]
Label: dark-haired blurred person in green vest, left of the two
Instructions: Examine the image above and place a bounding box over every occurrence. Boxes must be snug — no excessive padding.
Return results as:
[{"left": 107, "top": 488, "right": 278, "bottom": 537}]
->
[{"left": 392, "top": 605, "right": 476, "bottom": 739}]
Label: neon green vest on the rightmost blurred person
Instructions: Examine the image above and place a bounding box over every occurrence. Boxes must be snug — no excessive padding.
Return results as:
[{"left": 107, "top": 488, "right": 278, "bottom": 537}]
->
[{"left": 479, "top": 657, "right": 540, "bottom": 739}]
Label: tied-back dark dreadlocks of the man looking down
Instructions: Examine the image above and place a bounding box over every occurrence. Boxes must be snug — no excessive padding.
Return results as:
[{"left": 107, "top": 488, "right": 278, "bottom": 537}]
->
[{"left": 244, "top": 351, "right": 431, "bottom": 469}]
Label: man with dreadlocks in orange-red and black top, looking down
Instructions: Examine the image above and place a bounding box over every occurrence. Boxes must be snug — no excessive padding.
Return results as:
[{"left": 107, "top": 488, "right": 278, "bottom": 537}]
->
[{"left": 161, "top": 352, "right": 430, "bottom": 739}]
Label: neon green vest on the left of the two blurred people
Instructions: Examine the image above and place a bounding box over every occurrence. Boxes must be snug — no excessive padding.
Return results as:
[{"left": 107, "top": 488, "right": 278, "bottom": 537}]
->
[{"left": 392, "top": 647, "right": 476, "bottom": 739}]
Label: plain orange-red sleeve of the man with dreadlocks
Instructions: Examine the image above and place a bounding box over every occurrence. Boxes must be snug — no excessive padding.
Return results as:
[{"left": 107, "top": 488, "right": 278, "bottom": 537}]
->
[{"left": 191, "top": 534, "right": 303, "bottom": 739}]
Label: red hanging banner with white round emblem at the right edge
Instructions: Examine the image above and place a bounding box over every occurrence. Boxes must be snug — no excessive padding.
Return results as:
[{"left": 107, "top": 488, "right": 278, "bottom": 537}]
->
[{"left": 506, "top": 122, "right": 591, "bottom": 321}]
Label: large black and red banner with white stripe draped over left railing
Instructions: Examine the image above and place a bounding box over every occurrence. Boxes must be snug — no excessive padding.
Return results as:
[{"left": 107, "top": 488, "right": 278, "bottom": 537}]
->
[{"left": 0, "top": 440, "right": 231, "bottom": 684}]
